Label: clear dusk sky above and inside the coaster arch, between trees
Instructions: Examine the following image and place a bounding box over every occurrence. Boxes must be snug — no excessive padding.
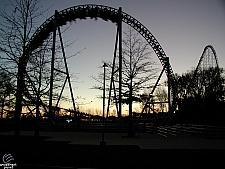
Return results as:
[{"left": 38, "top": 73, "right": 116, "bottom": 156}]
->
[{"left": 1, "top": 0, "right": 225, "bottom": 113}]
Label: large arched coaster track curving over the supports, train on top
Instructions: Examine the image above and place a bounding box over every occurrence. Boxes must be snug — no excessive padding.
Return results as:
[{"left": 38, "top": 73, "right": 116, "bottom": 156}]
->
[{"left": 22, "top": 4, "right": 178, "bottom": 110}]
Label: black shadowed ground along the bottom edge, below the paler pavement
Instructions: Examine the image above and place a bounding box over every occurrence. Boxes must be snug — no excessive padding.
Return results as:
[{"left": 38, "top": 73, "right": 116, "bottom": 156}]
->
[{"left": 0, "top": 135, "right": 225, "bottom": 169}]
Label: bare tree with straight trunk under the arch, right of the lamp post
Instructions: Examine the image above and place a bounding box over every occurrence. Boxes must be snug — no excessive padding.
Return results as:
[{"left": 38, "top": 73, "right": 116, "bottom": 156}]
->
[{"left": 93, "top": 27, "right": 157, "bottom": 136}]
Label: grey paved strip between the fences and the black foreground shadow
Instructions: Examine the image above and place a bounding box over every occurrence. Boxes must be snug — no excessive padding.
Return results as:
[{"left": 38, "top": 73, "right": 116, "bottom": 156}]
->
[{"left": 0, "top": 131, "right": 225, "bottom": 149}]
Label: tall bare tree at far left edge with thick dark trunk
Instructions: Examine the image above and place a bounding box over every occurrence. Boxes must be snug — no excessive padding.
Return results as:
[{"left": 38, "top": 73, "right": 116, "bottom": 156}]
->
[{"left": 0, "top": 0, "right": 47, "bottom": 139}]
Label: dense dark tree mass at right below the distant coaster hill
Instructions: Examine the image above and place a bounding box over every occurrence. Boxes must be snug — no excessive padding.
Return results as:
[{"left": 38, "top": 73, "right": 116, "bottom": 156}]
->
[{"left": 176, "top": 67, "right": 225, "bottom": 125}]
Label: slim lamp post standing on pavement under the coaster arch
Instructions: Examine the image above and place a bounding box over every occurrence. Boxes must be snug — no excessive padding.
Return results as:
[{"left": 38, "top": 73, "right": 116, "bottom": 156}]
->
[{"left": 100, "top": 63, "right": 108, "bottom": 146}]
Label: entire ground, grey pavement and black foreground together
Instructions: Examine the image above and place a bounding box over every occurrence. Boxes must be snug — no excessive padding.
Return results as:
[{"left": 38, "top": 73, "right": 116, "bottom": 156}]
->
[{"left": 0, "top": 131, "right": 225, "bottom": 168}]
